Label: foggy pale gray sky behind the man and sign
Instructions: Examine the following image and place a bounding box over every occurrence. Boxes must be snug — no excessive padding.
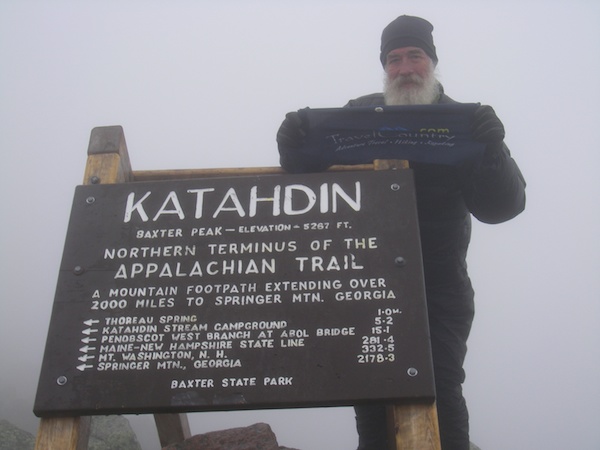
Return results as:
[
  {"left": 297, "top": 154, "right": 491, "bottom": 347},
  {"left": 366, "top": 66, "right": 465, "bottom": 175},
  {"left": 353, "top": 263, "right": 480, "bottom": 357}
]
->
[{"left": 0, "top": 0, "right": 600, "bottom": 450}]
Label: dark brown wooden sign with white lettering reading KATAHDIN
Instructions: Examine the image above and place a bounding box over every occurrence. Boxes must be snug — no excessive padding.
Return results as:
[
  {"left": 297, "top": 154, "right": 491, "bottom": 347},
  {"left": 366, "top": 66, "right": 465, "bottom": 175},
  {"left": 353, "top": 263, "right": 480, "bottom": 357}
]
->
[{"left": 34, "top": 170, "right": 434, "bottom": 416}]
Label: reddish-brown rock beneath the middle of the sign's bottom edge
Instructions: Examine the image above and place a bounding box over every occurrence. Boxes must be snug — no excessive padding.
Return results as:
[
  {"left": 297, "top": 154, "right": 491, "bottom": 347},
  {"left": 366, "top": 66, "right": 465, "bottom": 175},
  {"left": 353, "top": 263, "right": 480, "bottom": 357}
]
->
[{"left": 163, "top": 423, "right": 294, "bottom": 450}]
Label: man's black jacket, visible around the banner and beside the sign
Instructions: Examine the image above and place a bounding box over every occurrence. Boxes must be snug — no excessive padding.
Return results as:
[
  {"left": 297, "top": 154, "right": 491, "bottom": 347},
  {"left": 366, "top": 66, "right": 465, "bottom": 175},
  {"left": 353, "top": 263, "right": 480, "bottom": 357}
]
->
[{"left": 280, "top": 93, "right": 525, "bottom": 295}]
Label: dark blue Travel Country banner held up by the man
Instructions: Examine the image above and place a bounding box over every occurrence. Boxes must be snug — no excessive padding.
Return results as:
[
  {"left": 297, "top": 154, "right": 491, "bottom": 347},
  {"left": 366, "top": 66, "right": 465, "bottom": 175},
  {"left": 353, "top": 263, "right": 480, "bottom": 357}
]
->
[{"left": 299, "top": 103, "right": 485, "bottom": 165}]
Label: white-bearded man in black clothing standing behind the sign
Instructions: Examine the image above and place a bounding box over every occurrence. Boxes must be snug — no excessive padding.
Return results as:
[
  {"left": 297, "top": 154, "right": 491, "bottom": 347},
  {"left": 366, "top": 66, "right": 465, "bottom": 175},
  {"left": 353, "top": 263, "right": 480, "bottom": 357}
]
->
[{"left": 277, "top": 16, "right": 525, "bottom": 450}]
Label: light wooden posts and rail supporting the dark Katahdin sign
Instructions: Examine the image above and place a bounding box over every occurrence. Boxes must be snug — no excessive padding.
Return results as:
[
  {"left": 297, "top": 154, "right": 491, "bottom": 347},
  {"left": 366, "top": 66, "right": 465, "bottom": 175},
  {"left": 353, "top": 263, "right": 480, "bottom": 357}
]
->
[{"left": 35, "top": 126, "right": 441, "bottom": 450}]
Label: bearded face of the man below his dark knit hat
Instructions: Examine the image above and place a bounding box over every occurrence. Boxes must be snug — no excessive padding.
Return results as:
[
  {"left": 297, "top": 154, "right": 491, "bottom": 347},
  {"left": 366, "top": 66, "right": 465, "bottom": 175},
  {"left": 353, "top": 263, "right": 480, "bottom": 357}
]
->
[{"left": 384, "top": 47, "right": 439, "bottom": 105}]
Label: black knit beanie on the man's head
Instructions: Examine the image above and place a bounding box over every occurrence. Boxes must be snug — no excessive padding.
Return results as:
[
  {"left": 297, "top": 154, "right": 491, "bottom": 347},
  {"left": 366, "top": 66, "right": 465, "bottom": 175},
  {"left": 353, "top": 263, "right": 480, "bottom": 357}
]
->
[{"left": 379, "top": 16, "right": 437, "bottom": 67}]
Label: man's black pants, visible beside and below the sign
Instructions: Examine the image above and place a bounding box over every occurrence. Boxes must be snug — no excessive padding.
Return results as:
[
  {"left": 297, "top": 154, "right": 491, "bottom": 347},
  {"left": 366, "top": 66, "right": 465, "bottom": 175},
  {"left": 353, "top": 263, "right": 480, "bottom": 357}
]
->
[{"left": 354, "top": 284, "right": 474, "bottom": 450}]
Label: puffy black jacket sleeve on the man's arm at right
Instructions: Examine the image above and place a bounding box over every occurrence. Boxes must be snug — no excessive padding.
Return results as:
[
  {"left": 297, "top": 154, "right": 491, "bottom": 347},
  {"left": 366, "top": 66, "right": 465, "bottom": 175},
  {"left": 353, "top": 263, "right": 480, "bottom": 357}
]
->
[{"left": 463, "top": 142, "right": 526, "bottom": 224}]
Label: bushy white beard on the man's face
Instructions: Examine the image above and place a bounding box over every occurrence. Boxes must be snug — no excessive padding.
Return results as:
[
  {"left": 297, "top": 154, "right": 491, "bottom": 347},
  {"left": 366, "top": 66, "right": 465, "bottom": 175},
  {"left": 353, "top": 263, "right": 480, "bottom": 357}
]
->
[{"left": 383, "top": 65, "right": 440, "bottom": 105}]
